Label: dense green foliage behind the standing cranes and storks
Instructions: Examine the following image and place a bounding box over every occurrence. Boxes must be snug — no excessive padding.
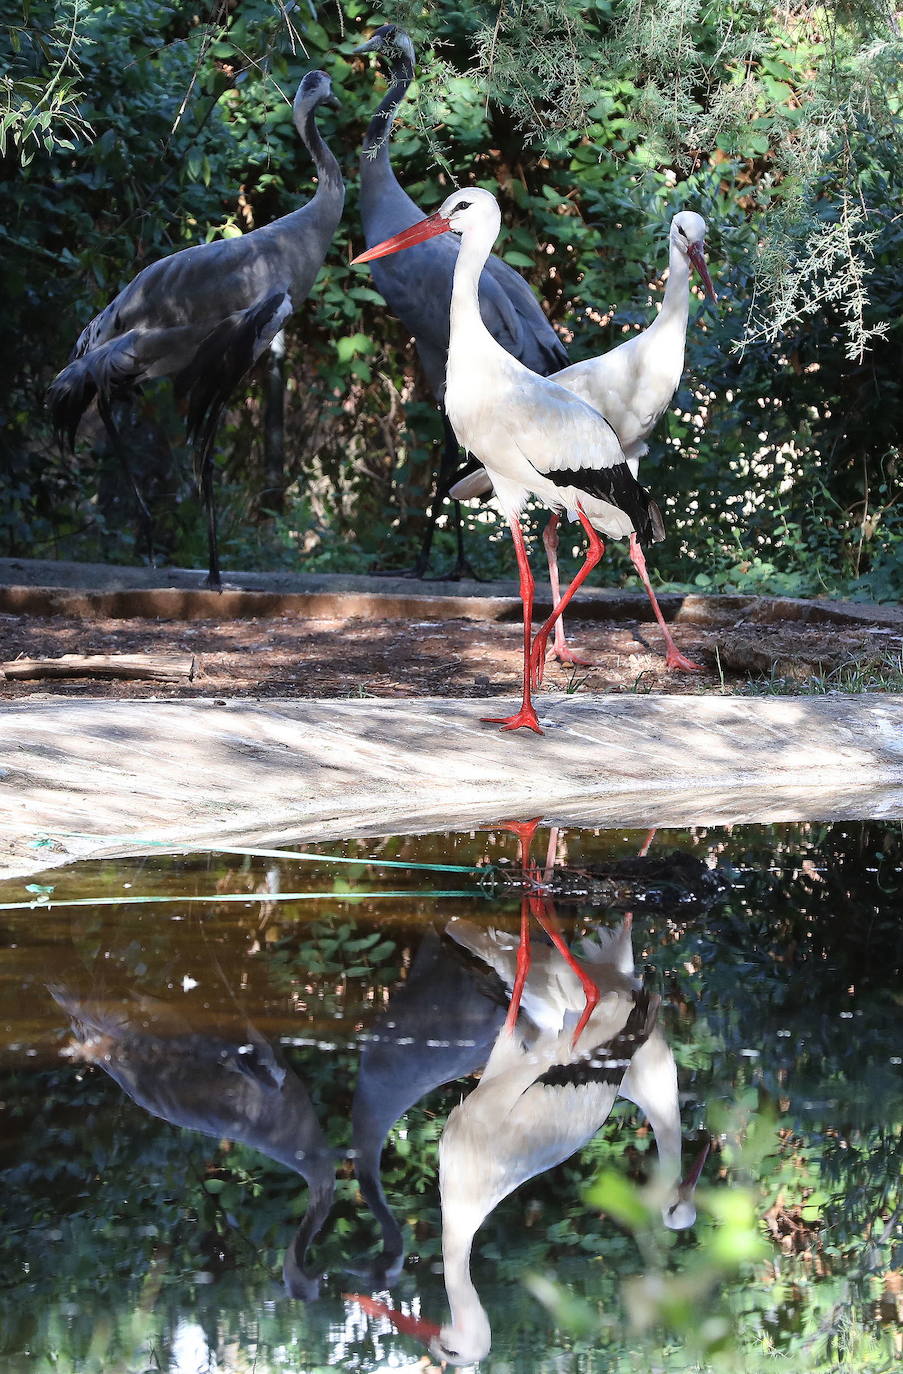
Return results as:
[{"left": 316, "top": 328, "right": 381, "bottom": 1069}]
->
[{"left": 0, "top": 0, "right": 903, "bottom": 598}]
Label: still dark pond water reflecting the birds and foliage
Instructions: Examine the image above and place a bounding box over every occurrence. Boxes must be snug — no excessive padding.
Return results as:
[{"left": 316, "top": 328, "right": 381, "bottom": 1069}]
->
[{"left": 0, "top": 822, "right": 903, "bottom": 1374}]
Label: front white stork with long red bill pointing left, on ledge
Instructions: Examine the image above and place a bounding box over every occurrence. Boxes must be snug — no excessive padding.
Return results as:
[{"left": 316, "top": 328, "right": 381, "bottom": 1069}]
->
[{"left": 353, "top": 187, "right": 664, "bottom": 735}]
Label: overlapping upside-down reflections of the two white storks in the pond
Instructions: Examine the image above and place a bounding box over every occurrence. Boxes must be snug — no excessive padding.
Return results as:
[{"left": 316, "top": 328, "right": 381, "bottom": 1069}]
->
[{"left": 359, "top": 822, "right": 708, "bottom": 1366}]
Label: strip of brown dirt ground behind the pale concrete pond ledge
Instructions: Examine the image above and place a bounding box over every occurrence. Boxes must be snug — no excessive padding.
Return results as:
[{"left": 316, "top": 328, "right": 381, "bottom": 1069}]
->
[{"left": 0, "top": 614, "right": 876, "bottom": 699}]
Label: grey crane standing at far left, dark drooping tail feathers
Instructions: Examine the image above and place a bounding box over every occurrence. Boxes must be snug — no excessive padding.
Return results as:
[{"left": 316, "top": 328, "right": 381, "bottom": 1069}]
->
[{"left": 47, "top": 71, "right": 345, "bottom": 587}]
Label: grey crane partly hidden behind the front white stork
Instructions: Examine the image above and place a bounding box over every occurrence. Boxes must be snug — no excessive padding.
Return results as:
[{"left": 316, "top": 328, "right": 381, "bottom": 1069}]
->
[{"left": 356, "top": 23, "right": 568, "bottom": 577}]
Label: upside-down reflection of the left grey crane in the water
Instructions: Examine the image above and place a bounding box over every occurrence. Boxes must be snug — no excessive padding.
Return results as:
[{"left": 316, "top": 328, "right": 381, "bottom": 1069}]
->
[{"left": 49, "top": 985, "right": 337, "bottom": 1301}]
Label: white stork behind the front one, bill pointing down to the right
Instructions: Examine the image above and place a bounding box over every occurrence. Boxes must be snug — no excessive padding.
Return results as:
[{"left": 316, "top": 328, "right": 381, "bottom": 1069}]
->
[{"left": 449, "top": 210, "right": 715, "bottom": 672}]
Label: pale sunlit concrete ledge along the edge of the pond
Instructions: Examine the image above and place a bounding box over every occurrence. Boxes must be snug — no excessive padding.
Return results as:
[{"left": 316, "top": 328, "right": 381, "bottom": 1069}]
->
[{"left": 0, "top": 695, "right": 903, "bottom": 877}]
